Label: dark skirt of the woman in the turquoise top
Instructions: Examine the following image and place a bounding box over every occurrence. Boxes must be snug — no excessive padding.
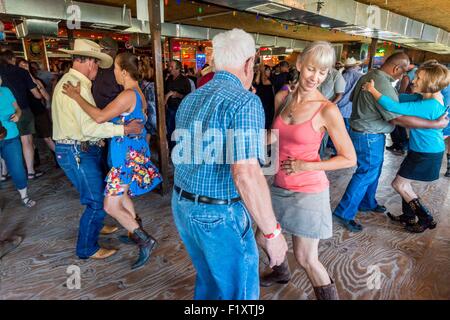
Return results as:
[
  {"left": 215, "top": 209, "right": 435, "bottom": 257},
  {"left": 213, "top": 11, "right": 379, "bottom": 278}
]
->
[{"left": 397, "top": 150, "right": 444, "bottom": 181}]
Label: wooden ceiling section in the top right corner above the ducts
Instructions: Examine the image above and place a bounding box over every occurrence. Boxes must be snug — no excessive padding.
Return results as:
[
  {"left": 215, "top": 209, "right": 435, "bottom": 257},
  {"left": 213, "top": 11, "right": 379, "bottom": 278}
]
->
[{"left": 357, "top": 0, "right": 450, "bottom": 32}]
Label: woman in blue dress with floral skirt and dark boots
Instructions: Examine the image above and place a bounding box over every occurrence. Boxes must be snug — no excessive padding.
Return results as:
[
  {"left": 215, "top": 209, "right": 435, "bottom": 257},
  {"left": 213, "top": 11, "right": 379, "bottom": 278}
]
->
[{"left": 63, "top": 52, "right": 161, "bottom": 269}]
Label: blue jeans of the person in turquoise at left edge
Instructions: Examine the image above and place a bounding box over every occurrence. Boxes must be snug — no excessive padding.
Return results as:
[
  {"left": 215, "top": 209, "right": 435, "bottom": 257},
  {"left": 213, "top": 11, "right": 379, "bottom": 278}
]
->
[{"left": 0, "top": 137, "right": 28, "bottom": 190}]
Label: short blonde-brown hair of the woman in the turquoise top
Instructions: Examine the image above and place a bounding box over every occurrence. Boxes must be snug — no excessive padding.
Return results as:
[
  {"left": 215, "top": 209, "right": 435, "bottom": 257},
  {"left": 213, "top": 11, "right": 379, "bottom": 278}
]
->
[{"left": 417, "top": 60, "right": 450, "bottom": 93}]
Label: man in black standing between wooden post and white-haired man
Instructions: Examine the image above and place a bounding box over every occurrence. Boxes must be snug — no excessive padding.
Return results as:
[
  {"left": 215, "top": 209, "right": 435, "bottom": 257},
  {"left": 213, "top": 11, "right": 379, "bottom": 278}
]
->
[{"left": 164, "top": 60, "right": 191, "bottom": 151}]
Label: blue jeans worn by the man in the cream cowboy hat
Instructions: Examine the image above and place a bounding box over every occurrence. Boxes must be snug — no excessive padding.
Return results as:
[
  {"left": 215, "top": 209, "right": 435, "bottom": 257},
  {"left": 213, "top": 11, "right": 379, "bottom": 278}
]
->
[{"left": 55, "top": 143, "right": 106, "bottom": 259}]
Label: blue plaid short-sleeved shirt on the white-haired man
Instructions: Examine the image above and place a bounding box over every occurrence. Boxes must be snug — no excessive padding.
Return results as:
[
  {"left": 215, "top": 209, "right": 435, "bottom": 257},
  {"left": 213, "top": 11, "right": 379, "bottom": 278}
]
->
[{"left": 172, "top": 71, "right": 265, "bottom": 199}]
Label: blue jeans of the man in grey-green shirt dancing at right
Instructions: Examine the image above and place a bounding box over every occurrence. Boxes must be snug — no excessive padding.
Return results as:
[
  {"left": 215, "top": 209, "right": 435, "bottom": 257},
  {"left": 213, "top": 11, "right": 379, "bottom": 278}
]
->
[{"left": 334, "top": 130, "right": 386, "bottom": 220}]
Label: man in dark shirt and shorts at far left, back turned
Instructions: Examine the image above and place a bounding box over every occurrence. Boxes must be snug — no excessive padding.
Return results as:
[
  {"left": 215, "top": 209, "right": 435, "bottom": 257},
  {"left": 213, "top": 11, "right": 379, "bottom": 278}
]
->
[{"left": 0, "top": 50, "right": 43, "bottom": 179}]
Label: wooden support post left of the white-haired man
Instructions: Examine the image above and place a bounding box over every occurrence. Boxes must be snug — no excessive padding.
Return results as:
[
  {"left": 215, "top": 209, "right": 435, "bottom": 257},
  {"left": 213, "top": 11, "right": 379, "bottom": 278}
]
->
[{"left": 148, "top": 0, "right": 169, "bottom": 195}]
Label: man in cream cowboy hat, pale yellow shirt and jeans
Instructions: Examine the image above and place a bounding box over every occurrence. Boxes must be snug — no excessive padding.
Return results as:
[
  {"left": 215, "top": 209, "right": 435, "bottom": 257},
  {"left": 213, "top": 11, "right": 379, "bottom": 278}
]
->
[{"left": 52, "top": 39, "right": 143, "bottom": 259}]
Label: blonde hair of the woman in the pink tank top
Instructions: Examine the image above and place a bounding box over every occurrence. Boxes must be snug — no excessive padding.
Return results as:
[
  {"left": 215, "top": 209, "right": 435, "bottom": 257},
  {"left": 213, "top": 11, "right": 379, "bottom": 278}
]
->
[{"left": 297, "top": 41, "right": 336, "bottom": 69}]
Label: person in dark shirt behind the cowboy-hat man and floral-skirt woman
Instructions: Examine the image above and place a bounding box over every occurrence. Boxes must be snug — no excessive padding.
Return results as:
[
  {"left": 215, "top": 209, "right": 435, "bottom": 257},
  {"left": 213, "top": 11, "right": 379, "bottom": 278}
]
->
[{"left": 92, "top": 38, "right": 123, "bottom": 109}]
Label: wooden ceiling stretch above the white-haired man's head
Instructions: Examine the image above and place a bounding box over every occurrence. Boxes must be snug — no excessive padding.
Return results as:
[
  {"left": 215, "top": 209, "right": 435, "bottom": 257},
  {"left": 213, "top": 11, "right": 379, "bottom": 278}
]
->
[{"left": 81, "top": 0, "right": 370, "bottom": 42}]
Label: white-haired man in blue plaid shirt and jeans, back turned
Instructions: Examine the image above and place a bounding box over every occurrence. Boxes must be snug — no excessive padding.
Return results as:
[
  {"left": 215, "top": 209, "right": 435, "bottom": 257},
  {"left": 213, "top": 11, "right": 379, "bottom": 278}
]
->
[{"left": 172, "top": 29, "right": 287, "bottom": 300}]
